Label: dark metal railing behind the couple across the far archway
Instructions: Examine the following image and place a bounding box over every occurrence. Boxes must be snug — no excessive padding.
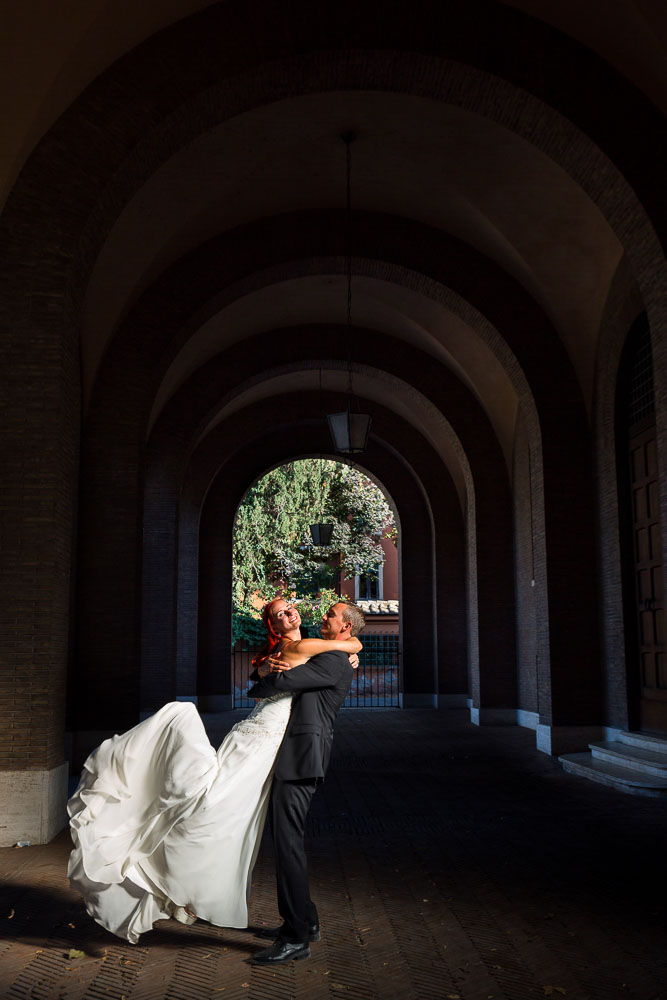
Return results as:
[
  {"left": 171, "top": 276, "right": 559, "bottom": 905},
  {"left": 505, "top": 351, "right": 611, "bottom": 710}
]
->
[{"left": 232, "top": 632, "right": 400, "bottom": 708}]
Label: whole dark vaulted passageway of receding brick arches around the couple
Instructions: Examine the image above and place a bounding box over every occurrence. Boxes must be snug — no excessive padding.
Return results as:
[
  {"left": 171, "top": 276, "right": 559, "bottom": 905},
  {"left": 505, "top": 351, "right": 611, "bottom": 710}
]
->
[{"left": 0, "top": 0, "right": 667, "bottom": 839}]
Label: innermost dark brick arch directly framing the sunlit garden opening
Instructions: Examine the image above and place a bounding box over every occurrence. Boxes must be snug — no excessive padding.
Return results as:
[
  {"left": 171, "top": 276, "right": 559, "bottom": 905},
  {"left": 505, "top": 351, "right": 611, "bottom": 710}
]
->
[{"left": 189, "top": 398, "right": 464, "bottom": 707}]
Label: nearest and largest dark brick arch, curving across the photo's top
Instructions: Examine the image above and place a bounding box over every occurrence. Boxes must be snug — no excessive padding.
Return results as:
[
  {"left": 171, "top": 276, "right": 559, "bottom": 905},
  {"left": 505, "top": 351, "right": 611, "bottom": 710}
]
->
[{"left": 0, "top": 3, "right": 667, "bottom": 752}]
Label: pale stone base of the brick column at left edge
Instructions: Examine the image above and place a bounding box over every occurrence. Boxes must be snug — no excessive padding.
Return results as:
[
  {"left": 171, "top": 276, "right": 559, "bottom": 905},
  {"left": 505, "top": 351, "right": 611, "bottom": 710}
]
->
[{"left": 0, "top": 761, "right": 69, "bottom": 847}]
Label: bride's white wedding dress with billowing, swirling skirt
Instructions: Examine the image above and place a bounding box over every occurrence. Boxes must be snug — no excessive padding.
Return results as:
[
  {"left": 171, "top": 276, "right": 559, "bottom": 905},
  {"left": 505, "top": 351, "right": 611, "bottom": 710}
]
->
[{"left": 68, "top": 694, "right": 292, "bottom": 944}]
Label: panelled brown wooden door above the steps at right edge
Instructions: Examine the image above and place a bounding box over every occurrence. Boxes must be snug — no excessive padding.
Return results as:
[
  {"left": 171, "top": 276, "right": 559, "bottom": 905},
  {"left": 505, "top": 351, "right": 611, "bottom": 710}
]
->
[{"left": 629, "top": 426, "right": 667, "bottom": 734}]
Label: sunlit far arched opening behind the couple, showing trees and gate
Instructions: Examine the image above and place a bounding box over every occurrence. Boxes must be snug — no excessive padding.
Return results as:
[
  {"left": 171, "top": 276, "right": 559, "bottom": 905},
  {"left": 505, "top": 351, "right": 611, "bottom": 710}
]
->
[{"left": 222, "top": 460, "right": 403, "bottom": 710}]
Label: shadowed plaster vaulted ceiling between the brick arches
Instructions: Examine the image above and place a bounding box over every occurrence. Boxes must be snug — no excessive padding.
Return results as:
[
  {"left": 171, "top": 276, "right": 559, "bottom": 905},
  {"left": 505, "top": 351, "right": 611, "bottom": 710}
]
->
[{"left": 0, "top": 0, "right": 667, "bottom": 488}]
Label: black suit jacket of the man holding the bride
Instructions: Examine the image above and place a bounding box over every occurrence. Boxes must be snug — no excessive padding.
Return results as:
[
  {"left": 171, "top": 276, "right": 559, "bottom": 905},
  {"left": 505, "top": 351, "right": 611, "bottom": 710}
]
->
[{"left": 248, "top": 650, "right": 354, "bottom": 781}]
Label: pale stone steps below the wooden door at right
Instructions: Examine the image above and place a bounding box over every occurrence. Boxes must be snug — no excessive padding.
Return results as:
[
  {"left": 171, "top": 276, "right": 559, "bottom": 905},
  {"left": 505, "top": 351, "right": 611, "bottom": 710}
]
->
[{"left": 558, "top": 733, "right": 667, "bottom": 798}]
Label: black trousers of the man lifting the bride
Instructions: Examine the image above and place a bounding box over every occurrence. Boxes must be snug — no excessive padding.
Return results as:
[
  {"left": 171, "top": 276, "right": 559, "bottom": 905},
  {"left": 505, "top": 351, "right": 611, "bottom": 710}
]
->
[{"left": 269, "top": 778, "right": 319, "bottom": 942}]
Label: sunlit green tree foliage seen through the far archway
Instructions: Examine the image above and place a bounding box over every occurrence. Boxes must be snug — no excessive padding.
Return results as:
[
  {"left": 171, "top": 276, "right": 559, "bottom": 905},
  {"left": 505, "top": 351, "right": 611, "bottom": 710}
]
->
[{"left": 233, "top": 459, "right": 393, "bottom": 616}]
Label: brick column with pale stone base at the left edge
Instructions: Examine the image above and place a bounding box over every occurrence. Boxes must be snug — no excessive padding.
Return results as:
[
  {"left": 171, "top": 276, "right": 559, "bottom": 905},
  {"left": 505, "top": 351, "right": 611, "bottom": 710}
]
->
[{"left": 0, "top": 258, "right": 80, "bottom": 847}]
